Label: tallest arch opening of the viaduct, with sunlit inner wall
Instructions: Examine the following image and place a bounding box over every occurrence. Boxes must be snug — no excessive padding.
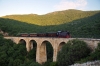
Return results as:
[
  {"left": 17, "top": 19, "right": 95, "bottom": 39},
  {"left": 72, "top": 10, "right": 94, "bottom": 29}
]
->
[{"left": 40, "top": 41, "right": 53, "bottom": 63}]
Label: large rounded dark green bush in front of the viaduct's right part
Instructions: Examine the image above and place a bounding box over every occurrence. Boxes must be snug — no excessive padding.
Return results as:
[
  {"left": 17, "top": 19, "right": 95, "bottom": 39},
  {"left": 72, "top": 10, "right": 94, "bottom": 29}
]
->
[{"left": 57, "top": 39, "right": 90, "bottom": 66}]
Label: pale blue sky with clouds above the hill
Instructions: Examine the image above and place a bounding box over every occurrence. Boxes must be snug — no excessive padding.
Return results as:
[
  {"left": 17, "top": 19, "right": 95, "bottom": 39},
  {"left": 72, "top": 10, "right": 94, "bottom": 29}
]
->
[{"left": 0, "top": 0, "right": 100, "bottom": 16}]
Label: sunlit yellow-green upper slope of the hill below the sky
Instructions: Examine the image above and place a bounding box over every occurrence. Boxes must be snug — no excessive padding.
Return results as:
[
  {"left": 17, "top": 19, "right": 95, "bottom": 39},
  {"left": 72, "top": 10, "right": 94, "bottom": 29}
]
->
[{"left": 4, "top": 10, "right": 100, "bottom": 26}]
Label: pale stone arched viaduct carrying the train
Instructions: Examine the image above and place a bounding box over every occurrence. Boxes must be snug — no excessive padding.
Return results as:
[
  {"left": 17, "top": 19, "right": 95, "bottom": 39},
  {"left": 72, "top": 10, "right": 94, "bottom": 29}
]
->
[{"left": 4, "top": 37, "right": 100, "bottom": 63}]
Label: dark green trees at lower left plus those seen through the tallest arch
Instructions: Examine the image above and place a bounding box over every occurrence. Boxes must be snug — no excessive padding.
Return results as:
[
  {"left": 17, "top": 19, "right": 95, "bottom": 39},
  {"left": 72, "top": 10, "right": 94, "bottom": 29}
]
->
[{"left": 0, "top": 35, "right": 53, "bottom": 66}]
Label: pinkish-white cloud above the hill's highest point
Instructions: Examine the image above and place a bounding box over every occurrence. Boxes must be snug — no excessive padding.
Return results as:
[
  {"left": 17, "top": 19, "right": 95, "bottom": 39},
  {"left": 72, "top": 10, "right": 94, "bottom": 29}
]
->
[{"left": 55, "top": 0, "right": 87, "bottom": 10}]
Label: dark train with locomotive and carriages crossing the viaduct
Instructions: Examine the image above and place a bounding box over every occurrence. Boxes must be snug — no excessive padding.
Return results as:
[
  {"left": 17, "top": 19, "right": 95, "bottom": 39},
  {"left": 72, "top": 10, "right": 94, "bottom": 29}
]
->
[{"left": 18, "top": 31, "right": 71, "bottom": 38}]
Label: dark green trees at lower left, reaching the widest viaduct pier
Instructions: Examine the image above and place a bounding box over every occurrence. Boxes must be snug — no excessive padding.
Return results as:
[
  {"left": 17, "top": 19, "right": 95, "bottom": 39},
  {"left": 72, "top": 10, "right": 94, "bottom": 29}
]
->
[{"left": 0, "top": 35, "right": 41, "bottom": 66}]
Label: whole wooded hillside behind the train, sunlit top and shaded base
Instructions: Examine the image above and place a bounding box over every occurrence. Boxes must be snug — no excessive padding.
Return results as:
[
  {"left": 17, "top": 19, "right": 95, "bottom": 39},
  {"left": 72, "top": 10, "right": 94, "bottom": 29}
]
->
[{"left": 0, "top": 10, "right": 100, "bottom": 38}]
